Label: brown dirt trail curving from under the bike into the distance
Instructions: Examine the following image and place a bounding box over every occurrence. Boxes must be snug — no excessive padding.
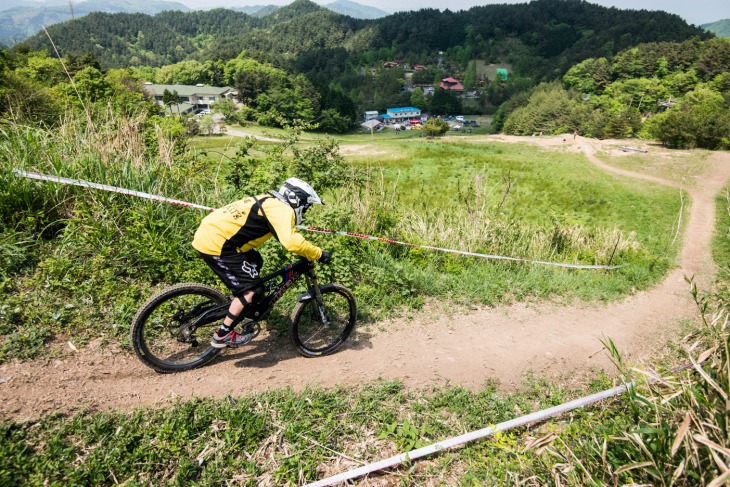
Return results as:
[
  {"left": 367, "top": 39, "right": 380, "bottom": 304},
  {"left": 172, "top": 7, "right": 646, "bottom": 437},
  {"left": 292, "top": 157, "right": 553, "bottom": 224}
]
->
[{"left": 0, "top": 137, "right": 730, "bottom": 419}]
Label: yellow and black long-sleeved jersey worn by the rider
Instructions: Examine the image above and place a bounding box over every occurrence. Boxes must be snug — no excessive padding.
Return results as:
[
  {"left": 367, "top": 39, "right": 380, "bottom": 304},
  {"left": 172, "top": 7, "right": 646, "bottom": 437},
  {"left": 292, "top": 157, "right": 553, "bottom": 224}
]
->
[{"left": 193, "top": 194, "right": 322, "bottom": 260}]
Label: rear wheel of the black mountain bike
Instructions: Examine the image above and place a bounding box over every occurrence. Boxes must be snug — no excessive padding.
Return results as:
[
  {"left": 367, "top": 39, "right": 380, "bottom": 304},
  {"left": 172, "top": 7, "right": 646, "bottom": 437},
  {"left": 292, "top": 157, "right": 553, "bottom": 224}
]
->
[{"left": 130, "top": 283, "right": 228, "bottom": 373}]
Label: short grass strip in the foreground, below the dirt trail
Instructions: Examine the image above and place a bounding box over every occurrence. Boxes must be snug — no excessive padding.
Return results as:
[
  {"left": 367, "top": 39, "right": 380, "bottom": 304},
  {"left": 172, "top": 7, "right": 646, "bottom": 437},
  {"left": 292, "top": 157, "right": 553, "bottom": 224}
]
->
[{"left": 0, "top": 382, "right": 624, "bottom": 485}]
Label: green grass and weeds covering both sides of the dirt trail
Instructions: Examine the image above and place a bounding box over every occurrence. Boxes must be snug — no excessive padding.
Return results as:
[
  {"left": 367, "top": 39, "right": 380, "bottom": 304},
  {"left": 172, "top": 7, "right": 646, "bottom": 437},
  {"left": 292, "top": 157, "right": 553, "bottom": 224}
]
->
[{"left": 0, "top": 110, "right": 730, "bottom": 486}]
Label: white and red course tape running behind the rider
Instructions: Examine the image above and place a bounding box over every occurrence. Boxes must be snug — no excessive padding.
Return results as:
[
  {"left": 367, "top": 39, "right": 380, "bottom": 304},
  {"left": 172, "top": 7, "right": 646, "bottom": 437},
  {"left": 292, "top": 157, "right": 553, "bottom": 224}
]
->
[{"left": 13, "top": 169, "right": 624, "bottom": 269}]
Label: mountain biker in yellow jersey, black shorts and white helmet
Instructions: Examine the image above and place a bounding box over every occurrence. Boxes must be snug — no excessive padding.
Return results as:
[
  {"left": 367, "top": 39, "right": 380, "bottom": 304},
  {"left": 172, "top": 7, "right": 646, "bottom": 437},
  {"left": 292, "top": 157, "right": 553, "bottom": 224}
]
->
[{"left": 193, "top": 178, "right": 330, "bottom": 348}]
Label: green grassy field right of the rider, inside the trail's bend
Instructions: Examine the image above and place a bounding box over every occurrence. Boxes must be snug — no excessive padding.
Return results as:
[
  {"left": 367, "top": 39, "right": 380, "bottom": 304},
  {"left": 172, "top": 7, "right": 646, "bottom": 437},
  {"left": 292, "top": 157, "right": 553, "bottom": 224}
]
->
[{"left": 189, "top": 133, "right": 691, "bottom": 309}]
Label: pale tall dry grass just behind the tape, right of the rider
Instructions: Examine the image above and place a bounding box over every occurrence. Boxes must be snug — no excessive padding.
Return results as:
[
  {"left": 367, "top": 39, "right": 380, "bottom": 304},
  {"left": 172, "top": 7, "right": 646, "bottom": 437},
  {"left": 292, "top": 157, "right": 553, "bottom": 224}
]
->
[{"left": 335, "top": 172, "right": 641, "bottom": 264}]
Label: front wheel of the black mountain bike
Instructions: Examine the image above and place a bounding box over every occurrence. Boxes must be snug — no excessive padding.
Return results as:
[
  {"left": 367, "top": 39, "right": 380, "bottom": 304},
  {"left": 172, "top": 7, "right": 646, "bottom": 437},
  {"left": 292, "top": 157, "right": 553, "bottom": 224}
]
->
[{"left": 290, "top": 284, "right": 357, "bottom": 357}]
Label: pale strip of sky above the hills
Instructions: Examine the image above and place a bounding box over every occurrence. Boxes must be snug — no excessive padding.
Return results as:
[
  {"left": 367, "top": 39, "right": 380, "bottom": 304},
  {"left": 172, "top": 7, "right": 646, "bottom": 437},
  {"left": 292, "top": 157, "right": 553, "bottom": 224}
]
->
[{"left": 174, "top": 0, "right": 730, "bottom": 25}]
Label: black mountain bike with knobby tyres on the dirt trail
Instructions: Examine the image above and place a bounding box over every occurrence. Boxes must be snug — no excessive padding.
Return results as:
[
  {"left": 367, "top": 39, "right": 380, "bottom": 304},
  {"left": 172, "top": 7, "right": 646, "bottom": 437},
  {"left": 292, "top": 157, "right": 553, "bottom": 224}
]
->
[{"left": 130, "top": 259, "right": 357, "bottom": 373}]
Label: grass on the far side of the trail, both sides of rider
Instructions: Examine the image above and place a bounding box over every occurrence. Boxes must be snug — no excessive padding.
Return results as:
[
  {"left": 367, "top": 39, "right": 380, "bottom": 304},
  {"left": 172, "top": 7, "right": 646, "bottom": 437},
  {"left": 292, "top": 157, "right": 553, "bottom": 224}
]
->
[{"left": 0, "top": 112, "right": 674, "bottom": 360}]
